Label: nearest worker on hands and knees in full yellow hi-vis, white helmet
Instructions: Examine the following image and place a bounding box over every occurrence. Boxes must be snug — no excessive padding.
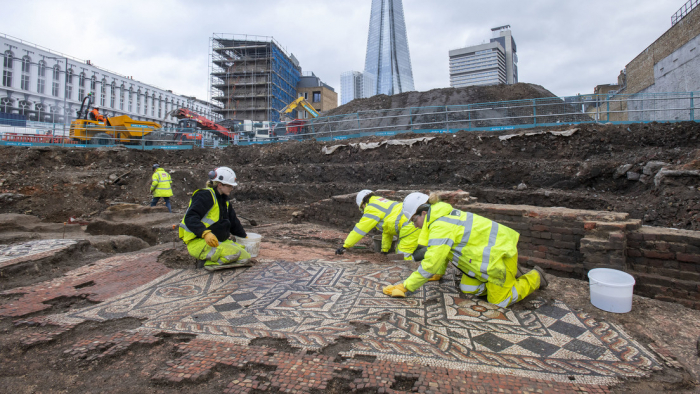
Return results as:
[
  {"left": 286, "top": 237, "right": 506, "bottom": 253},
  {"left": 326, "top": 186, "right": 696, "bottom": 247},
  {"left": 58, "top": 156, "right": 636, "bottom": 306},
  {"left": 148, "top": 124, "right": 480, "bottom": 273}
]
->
[{"left": 384, "top": 193, "right": 547, "bottom": 308}]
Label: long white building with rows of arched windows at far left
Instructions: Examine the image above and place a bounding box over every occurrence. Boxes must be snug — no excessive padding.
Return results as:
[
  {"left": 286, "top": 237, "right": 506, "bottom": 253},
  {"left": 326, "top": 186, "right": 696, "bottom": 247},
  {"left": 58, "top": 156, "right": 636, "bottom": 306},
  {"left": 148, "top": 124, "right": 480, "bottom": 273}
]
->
[{"left": 0, "top": 34, "right": 217, "bottom": 127}]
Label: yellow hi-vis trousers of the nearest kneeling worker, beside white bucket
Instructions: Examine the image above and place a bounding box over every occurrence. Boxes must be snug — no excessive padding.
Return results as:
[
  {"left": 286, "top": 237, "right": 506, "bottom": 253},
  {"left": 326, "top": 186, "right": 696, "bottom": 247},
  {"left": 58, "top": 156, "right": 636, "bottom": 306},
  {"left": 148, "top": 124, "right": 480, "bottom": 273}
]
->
[{"left": 459, "top": 254, "right": 540, "bottom": 308}]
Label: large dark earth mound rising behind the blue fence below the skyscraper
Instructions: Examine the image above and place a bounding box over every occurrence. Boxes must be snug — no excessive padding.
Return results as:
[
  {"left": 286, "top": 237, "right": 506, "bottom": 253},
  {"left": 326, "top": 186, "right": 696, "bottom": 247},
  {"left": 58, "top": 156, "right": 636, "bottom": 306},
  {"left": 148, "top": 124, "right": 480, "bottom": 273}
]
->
[{"left": 322, "top": 83, "right": 556, "bottom": 116}]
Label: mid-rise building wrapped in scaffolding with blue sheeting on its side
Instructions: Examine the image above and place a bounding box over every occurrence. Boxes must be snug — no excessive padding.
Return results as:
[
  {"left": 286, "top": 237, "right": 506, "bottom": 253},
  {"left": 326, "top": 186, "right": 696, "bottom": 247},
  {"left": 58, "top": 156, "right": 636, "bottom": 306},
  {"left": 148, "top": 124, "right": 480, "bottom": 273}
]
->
[{"left": 209, "top": 33, "right": 301, "bottom": 122}]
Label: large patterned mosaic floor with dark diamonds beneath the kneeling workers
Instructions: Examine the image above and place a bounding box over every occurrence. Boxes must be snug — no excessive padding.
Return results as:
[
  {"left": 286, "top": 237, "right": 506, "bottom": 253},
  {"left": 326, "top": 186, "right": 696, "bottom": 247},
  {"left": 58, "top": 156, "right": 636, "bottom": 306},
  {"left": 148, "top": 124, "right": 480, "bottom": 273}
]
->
[{"left": 52, "top": 260, "right": 659, "bottom": 384}]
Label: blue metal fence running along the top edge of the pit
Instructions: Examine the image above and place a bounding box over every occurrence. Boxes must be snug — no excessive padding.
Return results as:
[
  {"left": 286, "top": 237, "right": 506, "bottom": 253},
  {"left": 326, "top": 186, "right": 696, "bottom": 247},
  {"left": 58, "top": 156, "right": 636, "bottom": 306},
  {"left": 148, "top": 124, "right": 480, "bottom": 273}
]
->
[{"left": 0, "top": 92, "right": 700, "bottom": 150}]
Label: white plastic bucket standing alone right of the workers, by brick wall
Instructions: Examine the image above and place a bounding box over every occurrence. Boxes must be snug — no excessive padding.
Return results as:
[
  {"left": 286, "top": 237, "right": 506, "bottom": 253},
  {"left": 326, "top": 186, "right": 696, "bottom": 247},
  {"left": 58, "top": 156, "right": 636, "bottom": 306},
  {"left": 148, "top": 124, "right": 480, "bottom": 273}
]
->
[{"left": 588, "top": 268, "right": 634, "bottom": 313}]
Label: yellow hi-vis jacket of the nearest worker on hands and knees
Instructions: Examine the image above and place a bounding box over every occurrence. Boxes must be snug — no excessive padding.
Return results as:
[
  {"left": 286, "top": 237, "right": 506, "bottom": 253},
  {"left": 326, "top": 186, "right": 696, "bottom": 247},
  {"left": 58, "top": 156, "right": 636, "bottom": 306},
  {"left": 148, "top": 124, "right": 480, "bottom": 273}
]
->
[{"left": 404, "top": 202, "right": 520, "bottom": 291}]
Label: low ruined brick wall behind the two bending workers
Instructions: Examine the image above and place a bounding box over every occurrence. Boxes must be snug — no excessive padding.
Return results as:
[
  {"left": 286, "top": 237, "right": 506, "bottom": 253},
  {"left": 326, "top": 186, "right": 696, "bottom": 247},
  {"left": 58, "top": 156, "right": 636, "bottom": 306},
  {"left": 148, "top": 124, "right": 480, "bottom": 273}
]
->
[{"left": 295, "top": 190, "right": 700, "bottom": 309}]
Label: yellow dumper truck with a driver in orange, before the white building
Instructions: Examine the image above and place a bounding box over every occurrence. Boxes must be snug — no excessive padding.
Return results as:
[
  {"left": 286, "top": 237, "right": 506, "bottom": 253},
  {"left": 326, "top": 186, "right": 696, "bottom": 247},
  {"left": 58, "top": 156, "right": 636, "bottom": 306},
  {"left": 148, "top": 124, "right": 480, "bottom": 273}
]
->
[{"left": 70, "top": 95, "right": 165, "bottom": 145}]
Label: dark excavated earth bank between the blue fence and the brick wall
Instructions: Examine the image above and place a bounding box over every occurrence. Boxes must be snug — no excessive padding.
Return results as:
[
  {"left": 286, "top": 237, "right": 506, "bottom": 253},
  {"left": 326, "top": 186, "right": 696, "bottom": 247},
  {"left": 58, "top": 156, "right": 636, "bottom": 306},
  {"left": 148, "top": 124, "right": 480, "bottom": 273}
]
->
[{"left": 0, "top": 122, "right": 700, "bottom": 231}]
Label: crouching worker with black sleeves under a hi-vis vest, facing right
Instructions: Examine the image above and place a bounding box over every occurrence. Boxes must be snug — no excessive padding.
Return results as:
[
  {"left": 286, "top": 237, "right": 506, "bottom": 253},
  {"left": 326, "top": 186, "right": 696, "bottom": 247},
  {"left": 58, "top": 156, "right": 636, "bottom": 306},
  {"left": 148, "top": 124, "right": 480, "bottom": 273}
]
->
[{"left": 179, "top": 167, "right": 252, "bottom": 271}]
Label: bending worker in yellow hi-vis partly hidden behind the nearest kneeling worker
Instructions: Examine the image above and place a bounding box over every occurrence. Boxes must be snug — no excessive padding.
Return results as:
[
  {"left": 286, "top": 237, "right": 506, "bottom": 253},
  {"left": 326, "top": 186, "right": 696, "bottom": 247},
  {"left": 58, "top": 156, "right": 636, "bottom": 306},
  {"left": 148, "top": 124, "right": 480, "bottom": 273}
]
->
[{"left": 335, "top": 190, "right": 420, "bottom": 260}]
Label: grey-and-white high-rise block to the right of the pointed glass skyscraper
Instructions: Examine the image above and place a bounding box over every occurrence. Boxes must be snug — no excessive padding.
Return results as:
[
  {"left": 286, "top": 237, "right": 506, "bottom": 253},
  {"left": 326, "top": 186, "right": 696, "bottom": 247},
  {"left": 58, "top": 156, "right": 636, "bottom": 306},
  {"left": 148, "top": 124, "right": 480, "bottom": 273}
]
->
[{"left": 449, "top": 25, "right": 518, "bottom": 88}]
